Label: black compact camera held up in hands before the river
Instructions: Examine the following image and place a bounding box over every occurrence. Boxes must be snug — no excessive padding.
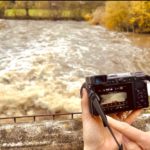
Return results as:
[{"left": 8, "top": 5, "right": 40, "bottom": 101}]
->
[{"left": 85, "top": 72, "right": 150, "bottom": 115}]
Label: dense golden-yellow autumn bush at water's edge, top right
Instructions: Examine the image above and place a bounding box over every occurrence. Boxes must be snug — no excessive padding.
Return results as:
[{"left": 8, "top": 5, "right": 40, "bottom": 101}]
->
[{"left": 103, "top": 1, "right": 150, "bottom": 33}]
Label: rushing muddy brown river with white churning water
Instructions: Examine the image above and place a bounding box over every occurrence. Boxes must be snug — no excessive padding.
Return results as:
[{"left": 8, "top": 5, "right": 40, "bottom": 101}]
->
[{"left": 0, "top": 20, "right": 150, "bottom": 116}]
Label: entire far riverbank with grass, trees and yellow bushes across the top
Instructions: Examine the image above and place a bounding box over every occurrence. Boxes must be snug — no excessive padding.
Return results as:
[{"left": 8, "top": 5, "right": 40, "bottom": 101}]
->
[{"left": 0, "top": 1, "right": 150, "bottom": 33}]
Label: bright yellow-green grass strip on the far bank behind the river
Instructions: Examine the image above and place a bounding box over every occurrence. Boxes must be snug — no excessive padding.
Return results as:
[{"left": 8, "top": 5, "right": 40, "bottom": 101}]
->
[{"left": 4, "top": 9, "right": 88, "bottom": 20}]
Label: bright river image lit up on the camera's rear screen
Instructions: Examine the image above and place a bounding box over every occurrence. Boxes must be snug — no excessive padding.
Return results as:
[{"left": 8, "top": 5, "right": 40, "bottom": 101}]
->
[{"left": 100, "top": 92, "right": 127, "bottom": 104}]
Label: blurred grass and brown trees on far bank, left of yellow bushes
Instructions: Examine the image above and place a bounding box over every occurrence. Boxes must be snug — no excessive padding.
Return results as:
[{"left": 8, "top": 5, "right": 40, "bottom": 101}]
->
[{"left": 0, "top": 0, "right": 104, "bottom": 20}]
